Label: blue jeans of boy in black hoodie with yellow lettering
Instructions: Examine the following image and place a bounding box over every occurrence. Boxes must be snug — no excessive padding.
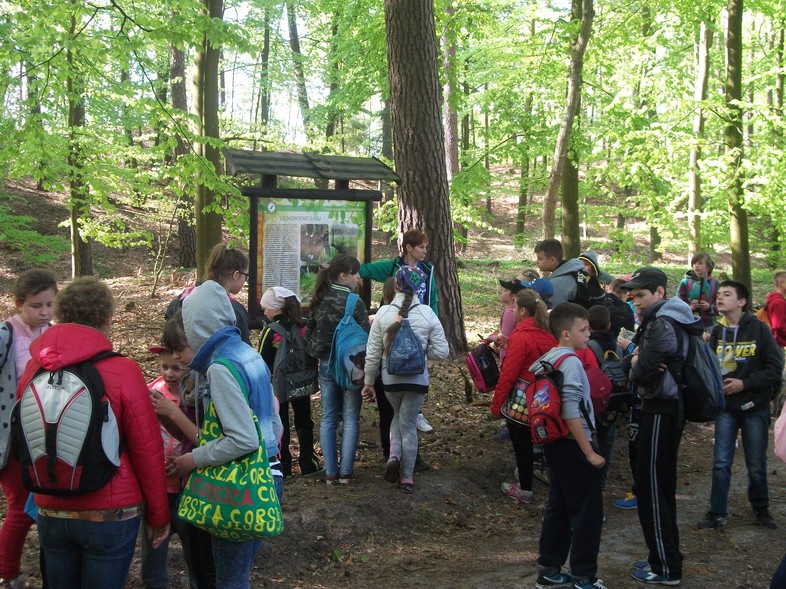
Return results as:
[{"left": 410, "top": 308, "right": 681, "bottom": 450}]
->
[{"left": 710, "top": 403, "right": 770, "bottom": 517}]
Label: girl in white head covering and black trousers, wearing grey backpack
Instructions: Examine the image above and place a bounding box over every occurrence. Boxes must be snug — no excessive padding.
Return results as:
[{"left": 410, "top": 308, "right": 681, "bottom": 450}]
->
[{"left": 259, "top": 286, "right": 321, "bottom": 476}]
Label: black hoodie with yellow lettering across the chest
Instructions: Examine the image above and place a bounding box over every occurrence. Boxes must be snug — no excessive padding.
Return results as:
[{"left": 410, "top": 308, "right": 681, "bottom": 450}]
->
[{"left": 710, "top": 313, "right": 783, "bottom": 409}]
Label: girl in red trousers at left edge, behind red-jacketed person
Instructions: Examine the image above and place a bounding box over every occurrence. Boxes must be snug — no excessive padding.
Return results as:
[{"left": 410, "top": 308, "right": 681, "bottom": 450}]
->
[{"left": 0, "top": 270, "right": 57, "bottom": 587}]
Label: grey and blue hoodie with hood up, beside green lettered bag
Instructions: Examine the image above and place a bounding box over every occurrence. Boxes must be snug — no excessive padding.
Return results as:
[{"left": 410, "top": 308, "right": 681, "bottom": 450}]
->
[{"left": 183, "top": 280, "right": 281, "bottom": 468}]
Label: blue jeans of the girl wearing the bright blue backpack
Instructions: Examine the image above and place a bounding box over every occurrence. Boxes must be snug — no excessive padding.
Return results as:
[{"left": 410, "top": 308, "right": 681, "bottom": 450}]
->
[{"left": 319, "top": 360, "right": 362, "bottom": 476}]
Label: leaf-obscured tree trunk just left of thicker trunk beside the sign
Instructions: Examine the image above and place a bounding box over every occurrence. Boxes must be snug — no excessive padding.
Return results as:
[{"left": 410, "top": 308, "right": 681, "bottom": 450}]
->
[{"left": 169, "top": 45, "right": 196, "bottom": 268}]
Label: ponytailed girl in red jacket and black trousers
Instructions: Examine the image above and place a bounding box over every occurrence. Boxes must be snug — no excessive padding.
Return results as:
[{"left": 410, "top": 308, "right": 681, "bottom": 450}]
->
[{"left": 491, "top": 289, "right": 557, "bottom": 503}]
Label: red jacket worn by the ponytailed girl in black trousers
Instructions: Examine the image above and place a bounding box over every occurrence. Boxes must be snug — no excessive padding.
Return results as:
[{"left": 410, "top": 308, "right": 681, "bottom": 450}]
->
[{"left": 491, "top": 317, "right": 557, "bottom": 418}]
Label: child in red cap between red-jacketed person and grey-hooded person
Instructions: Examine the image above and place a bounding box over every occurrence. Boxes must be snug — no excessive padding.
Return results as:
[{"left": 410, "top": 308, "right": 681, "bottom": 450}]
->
[{"left": 141, "top": 345, "right": 199, "bottom": 588}]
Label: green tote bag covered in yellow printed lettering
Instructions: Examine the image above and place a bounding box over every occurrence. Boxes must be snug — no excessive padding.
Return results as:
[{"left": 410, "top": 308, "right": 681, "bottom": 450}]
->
[{"left": 177, "top": 358, "right": 284, "bottom": 542}]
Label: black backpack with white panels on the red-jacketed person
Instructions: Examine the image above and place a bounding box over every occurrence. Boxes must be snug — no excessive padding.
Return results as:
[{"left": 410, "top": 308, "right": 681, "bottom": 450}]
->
[{"left": 11, "top": 352, "right": 121, "bottom": 496}]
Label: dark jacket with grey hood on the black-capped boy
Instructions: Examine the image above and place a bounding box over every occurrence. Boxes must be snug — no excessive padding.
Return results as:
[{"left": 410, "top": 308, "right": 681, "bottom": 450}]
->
[{"left": 622, "top": 298, "right": 704, "bottom": 413}]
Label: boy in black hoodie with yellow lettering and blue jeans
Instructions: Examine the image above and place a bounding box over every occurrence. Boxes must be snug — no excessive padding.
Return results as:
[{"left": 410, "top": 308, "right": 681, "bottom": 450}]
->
[{"left": 699, "top": 280, "right": 783, "bottom": 529}]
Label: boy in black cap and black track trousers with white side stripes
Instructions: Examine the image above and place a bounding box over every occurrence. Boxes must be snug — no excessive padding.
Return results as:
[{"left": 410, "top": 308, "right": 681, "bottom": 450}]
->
[{"left": 622, "top": 267, "right": 703, "bottom": 585}]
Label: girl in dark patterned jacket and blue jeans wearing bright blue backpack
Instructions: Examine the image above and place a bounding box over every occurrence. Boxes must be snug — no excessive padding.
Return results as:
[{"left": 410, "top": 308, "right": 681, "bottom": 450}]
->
[{"left": 306, "top": 254, "right": 369, "bottom": 485}]
